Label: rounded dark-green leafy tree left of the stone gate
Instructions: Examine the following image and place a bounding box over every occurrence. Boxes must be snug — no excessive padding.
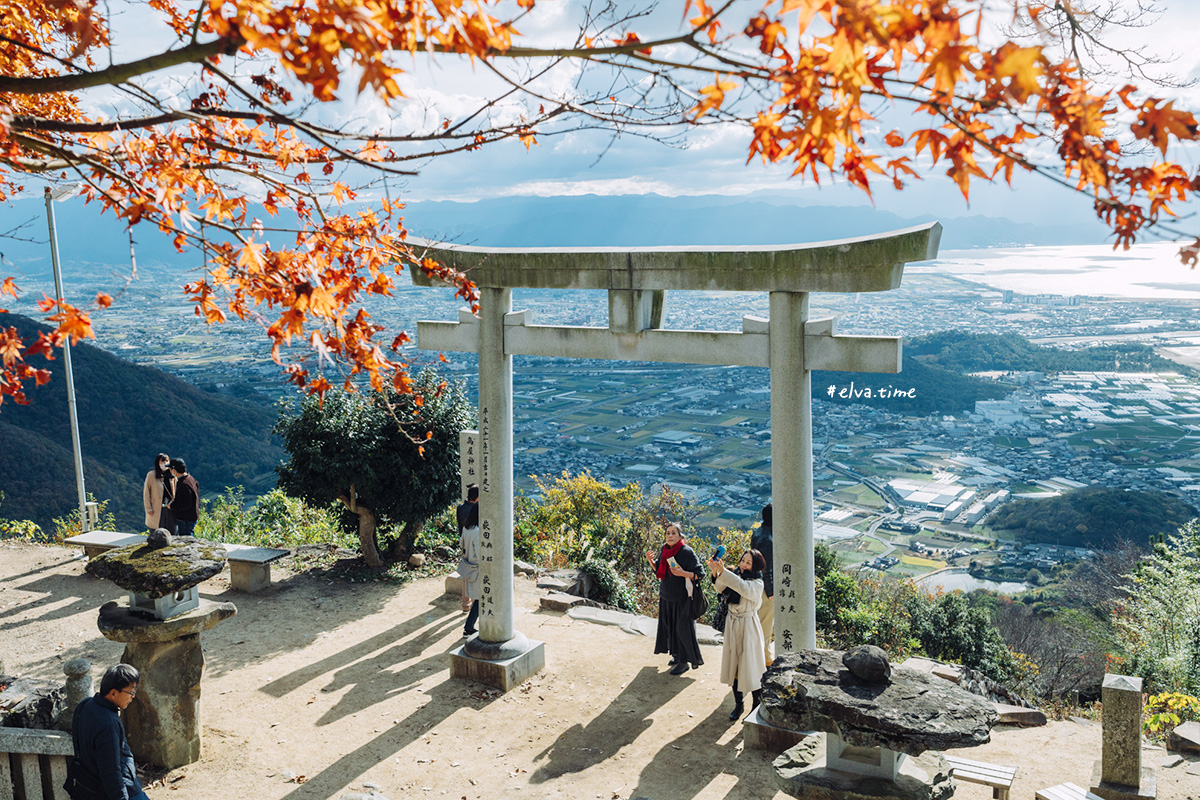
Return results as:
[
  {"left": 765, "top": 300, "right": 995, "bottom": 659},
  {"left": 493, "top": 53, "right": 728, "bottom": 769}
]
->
[{"left": 275, "top": 369, "right": 475, "bottom": 567}]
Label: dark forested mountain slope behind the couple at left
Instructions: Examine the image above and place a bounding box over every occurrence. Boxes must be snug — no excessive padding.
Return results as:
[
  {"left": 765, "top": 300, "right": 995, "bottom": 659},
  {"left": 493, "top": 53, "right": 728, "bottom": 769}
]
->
[{"left": 0, "top": 314, "right": 283, "bottom": 533}]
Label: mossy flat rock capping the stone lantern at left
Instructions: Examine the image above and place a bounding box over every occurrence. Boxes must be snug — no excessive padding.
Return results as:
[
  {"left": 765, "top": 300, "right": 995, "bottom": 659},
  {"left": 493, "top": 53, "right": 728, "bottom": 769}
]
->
[{"left": 88, "top": 536, "right": 226, "bottom": 600}]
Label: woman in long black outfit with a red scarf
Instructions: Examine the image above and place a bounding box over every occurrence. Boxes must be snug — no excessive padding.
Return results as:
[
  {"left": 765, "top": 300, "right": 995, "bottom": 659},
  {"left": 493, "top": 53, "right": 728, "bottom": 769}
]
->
[{"left": 646, "top": 522, "right": 704, "bottom": 675}]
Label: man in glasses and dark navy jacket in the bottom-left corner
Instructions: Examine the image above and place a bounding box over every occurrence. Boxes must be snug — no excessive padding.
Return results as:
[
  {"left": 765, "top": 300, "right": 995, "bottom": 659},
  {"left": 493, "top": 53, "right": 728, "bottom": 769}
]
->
[{"left": 71, "top": 664, "right": 149, "bottom": 800}]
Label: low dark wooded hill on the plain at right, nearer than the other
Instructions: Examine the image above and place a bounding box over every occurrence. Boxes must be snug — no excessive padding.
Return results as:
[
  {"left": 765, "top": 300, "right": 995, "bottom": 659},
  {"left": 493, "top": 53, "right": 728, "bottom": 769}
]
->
[{"left": 989, "top": 487, "right": 1196, "bottom": 548}]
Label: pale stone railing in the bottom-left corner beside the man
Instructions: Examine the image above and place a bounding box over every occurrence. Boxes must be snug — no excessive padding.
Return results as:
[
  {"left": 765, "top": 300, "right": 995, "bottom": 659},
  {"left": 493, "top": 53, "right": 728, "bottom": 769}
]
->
[{"left": 0, "top": 728, "right": 74, "bottom": 800}]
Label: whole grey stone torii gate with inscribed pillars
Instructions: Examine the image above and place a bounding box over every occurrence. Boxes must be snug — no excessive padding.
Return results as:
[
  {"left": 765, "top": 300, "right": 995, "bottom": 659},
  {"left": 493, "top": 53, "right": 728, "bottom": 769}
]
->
[{"left": 410, "top": 222, "right": 942, "bottom": 691}]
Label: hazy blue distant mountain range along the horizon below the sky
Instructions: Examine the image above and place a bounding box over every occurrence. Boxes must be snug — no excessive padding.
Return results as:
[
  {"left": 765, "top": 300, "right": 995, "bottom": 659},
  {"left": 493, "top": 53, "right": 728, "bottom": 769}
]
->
[{"left": 0, "top": 194, "right": 1105, "bottom": 282}]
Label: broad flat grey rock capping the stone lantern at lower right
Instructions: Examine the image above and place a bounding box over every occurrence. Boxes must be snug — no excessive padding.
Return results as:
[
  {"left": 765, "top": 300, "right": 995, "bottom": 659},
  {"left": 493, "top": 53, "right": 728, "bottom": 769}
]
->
[{"left": 762, "top": 650, "right": 997, "bottom": 756}]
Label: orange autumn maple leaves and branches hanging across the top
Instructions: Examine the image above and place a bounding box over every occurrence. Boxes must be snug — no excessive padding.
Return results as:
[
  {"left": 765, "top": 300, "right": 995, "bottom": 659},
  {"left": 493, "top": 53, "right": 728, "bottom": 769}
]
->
[{"left": 0, "top": 0, "right": 1200, "bottom": 404}]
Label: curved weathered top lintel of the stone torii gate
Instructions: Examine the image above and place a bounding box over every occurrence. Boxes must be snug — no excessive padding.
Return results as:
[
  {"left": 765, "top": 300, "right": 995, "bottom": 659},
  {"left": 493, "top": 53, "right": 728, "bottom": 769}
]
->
[{"left": 409, "top": 222, "right": 942, "bottom": 293}]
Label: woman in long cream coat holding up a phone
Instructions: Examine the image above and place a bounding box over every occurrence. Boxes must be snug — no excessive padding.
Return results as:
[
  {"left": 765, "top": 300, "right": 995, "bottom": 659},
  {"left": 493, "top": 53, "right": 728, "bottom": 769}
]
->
[{"left": 708, "top": 551, "right": 767, "bottom": 722}]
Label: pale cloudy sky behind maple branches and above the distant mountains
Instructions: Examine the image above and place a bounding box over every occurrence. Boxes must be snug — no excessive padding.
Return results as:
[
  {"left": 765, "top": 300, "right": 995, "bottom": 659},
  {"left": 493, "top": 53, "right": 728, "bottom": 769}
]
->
[{"left": 32, "top": 0, "right": 1200, "bottom": 235}]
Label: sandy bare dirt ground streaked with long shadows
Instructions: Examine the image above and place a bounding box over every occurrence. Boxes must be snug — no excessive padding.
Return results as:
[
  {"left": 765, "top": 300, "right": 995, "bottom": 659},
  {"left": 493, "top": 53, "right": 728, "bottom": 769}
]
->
[{"left": 0, "top": 543, "right": 1200, "bottom": 800}]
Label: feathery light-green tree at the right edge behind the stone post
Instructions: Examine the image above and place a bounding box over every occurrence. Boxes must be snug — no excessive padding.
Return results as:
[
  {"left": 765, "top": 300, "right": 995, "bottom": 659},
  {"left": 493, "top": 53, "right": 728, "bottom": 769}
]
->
[{"left": 1114, "top": 519, "right": 1200, "bottom": 694}]
